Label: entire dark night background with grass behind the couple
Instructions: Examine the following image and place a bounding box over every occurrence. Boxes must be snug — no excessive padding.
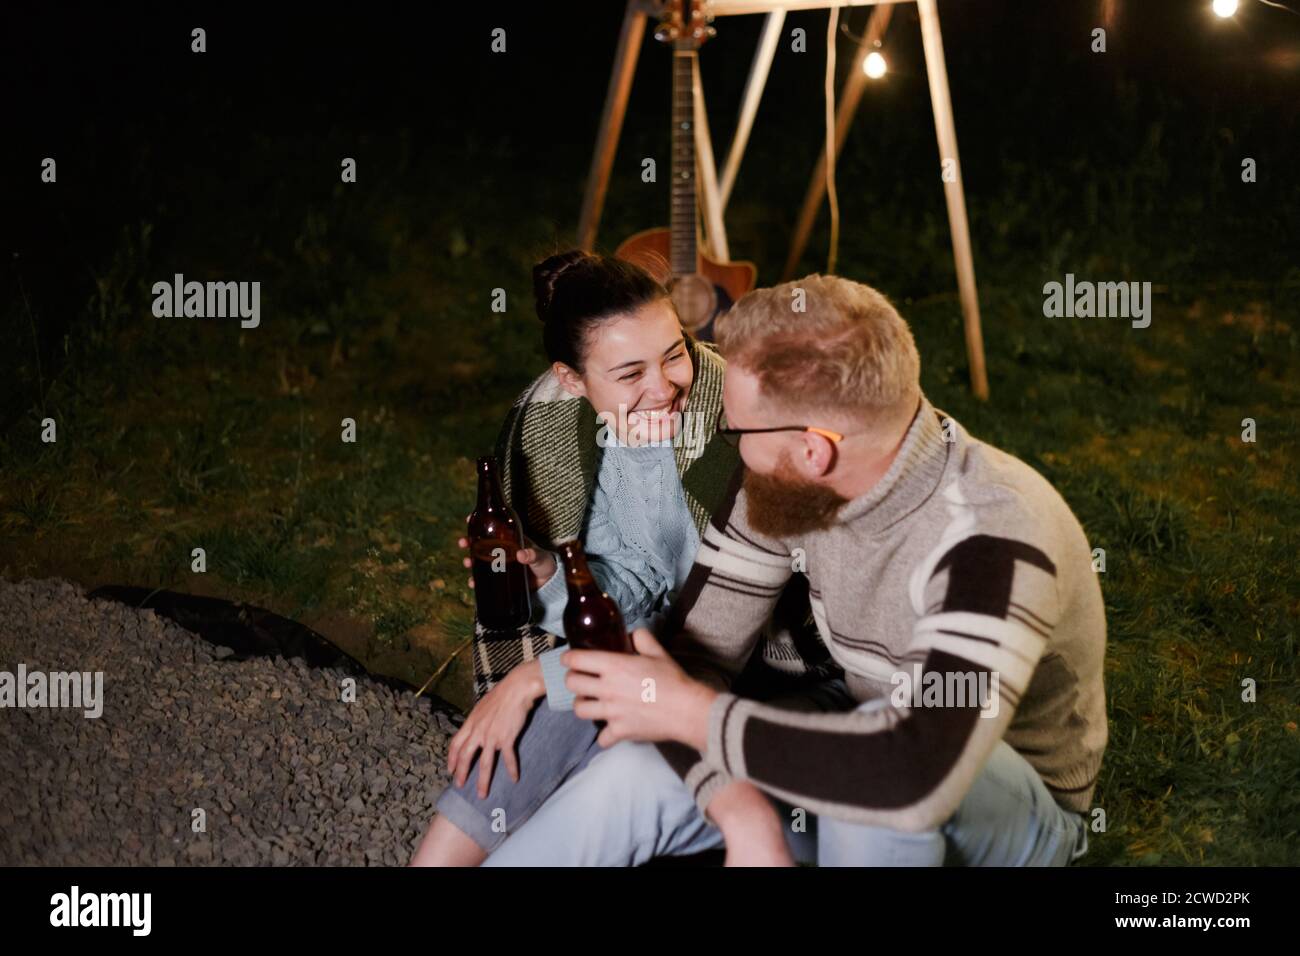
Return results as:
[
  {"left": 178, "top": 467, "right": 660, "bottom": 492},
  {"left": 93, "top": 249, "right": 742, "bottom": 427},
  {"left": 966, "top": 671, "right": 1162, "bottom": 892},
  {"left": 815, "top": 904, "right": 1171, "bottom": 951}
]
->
[{"left": 0, "top": 0, "right": 1300, "bottom": 864}]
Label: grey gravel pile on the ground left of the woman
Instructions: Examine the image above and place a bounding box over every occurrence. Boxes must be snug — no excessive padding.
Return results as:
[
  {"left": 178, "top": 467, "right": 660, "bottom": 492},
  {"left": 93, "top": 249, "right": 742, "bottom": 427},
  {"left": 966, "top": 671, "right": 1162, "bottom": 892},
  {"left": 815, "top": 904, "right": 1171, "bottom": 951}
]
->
[{"left": 0, "top": 579, "right": 456, "bottom": 866}]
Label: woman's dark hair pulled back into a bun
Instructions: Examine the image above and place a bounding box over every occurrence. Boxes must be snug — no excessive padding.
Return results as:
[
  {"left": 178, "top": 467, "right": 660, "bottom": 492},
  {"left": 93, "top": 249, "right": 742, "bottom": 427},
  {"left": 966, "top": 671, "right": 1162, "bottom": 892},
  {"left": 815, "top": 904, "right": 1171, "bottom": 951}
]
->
[{"left": 533, "top": 248, "right": 668, "bottom": 372}]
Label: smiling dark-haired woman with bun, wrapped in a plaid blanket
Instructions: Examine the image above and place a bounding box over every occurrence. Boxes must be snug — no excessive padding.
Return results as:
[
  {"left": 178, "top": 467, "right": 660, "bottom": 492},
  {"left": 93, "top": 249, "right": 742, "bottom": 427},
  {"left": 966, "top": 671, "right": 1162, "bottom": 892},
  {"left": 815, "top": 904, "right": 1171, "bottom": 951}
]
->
[{"left": 411, "top": 251, "right": 800, "bottom": 866}]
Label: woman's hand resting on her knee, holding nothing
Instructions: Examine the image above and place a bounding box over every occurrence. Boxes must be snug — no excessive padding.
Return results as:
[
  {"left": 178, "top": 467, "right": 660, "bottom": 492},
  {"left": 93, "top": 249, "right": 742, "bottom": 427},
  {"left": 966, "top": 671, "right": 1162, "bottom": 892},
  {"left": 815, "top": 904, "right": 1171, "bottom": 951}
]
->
[{"left": 447, "top": 661, "right": 546, "bottom": 800}]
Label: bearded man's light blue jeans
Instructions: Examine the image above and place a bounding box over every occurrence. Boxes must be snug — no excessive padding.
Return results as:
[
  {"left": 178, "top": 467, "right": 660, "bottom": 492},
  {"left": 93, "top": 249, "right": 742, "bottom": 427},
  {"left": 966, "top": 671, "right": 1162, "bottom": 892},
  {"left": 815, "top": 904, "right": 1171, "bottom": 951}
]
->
[{"left": 485, "top": 698, "right": 1088, "bottom": 866}]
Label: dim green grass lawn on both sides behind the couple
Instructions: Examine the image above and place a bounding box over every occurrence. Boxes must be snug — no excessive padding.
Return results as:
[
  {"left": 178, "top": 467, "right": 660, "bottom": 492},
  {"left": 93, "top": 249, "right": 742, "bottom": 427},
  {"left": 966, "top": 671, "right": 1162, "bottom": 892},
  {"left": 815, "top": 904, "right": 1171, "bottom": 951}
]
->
[{"left": 0, "top": 72, "right": 1300, "bottom": 865}]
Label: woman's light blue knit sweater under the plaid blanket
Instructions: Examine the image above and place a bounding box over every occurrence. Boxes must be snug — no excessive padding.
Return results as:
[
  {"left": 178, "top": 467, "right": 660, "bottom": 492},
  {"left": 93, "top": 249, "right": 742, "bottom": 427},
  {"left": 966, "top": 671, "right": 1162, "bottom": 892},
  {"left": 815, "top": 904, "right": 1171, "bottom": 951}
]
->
[{"left": 533, "top": 434, "right": 699, "bottom": 710}]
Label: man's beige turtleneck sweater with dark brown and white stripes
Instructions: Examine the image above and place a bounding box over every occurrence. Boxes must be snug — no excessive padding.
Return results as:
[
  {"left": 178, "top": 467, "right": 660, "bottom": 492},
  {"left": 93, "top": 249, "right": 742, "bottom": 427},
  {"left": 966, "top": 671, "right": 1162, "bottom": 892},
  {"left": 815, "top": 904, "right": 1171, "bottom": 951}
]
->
[{"left": 660, "top": 398, "right": 1106, "bottom": 831}]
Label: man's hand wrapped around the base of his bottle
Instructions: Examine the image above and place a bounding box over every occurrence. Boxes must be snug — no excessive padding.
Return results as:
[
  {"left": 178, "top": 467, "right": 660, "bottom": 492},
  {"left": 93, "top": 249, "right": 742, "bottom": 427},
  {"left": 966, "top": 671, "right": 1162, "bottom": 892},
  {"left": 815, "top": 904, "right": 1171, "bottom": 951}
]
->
[{"left": 560, "top": 627, "right": 718, "bottom": 753}]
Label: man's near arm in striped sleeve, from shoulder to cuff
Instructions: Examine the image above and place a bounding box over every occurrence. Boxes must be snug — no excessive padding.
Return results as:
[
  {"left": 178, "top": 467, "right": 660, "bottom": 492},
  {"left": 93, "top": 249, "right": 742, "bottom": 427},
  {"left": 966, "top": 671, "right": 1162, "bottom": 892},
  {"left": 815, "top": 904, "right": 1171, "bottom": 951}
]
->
[{"left": 706, "top": 535, "right": 1058, "bottom": 831}]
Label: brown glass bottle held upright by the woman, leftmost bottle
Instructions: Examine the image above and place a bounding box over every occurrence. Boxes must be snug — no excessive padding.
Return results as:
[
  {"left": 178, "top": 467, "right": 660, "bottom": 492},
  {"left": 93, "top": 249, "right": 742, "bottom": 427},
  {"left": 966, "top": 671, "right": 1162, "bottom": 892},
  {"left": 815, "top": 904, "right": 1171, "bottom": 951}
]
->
[{"left": 465, "top": 455, "right": 533, "bottom": 628}]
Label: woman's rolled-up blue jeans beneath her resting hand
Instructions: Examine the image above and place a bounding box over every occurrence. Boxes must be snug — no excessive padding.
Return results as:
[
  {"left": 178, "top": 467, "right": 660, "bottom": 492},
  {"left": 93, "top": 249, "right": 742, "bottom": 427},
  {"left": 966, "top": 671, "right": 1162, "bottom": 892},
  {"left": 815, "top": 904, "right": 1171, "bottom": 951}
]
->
[{"left": 437, "top": 697, "right": 601, "bottom": 852}]
